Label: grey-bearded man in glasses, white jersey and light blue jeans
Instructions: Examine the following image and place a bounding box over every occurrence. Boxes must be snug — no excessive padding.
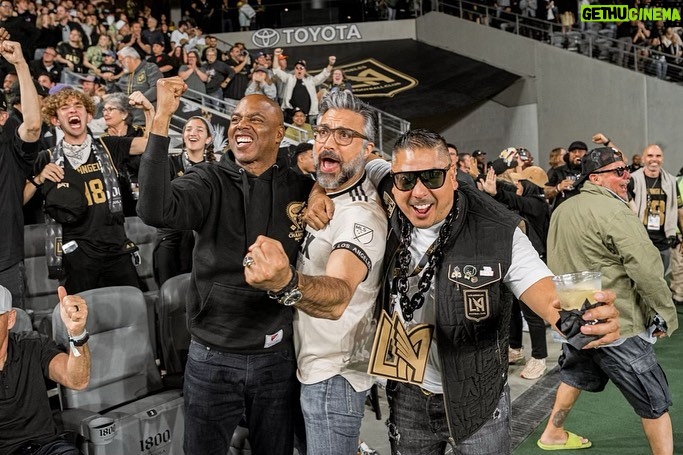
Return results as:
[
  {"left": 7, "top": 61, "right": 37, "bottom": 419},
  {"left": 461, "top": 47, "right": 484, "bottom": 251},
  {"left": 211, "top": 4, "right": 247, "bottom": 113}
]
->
[{"left": 245, "top": 92, "right": 387, "bottom": 455}]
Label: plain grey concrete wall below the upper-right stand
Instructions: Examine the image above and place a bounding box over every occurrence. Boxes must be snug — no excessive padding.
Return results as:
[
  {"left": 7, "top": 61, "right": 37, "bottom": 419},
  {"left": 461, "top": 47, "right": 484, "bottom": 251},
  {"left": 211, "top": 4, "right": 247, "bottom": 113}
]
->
[{"left": 416, "top": 13, "right": 683, "bottom": 173}]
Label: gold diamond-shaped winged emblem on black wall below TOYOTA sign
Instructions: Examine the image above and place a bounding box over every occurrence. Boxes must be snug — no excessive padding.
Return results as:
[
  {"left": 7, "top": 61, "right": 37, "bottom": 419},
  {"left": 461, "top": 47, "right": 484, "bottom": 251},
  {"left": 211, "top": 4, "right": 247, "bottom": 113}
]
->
[{"left": 316, "top": 58, "right": 417, "bottom": 98}]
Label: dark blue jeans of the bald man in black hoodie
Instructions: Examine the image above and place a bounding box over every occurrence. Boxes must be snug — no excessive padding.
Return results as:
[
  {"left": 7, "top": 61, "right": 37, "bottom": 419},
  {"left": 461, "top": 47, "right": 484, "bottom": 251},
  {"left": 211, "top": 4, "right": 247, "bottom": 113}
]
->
[{"left": 183, "top": 341, "right": 298, "bottom": 455}]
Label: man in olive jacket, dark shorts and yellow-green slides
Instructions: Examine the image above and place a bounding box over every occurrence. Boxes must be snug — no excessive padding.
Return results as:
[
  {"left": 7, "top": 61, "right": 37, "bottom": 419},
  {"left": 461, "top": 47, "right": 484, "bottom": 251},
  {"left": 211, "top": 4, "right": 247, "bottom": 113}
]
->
[{"left": 538, "top": 147, "right": 678, "bottom": 454}]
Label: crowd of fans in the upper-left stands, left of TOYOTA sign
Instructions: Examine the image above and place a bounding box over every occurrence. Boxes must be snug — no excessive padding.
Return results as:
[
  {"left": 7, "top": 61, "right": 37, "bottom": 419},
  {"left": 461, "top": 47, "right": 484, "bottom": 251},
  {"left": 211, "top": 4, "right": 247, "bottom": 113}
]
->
[{"left": 0, "top": 0, "right": 350, "bottom": 124}]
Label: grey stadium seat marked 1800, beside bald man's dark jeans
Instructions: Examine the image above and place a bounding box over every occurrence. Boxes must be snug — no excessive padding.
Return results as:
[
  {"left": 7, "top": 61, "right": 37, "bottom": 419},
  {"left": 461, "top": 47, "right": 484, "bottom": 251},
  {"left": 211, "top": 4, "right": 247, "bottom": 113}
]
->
[{"left": 52, "top": 286, "right": 184, "bottom": 455}]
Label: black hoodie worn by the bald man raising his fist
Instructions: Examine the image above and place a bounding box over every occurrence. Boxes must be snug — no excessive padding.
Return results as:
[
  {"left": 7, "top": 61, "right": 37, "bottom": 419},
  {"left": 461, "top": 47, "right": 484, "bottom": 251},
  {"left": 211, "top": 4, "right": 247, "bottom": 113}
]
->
[{"left": 137, "top": 134, "right": 313, "bottom": 354}]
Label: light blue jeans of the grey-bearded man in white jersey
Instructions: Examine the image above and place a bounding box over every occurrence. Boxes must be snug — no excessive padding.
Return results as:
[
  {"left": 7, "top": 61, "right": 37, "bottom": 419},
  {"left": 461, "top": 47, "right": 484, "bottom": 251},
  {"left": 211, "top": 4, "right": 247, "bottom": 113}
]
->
[{"left": 301, "top": 375, "right": 367, "bottom": 455}]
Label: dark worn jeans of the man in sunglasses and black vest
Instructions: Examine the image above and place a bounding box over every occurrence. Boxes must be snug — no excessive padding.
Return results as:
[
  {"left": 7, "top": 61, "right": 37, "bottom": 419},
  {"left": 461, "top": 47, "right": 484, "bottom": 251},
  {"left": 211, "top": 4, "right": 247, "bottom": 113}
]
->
[{"left": 387, "top": 381, "right": 512, "bottom": 455}]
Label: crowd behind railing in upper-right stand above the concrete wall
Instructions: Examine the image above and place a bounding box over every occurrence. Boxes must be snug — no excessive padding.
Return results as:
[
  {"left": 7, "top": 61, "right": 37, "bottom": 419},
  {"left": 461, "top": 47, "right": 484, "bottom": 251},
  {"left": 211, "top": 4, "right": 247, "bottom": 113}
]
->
[{"left": 440, "top": 0, "right": 683, "bottom": 81}]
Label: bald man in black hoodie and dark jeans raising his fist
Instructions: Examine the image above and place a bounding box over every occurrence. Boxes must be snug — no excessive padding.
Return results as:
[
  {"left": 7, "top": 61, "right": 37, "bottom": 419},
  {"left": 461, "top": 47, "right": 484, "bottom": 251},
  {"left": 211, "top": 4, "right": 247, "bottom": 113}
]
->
[{"left": 138, "top": 77, "right": 313, "bottom": 455}]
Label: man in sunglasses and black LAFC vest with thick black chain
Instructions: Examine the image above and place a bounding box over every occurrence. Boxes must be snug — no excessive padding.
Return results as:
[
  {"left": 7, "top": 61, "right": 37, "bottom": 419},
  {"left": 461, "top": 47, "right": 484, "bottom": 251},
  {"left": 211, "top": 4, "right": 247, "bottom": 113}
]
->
[{"left": 358, "top": 130, "right": 619, "bottom": 455}]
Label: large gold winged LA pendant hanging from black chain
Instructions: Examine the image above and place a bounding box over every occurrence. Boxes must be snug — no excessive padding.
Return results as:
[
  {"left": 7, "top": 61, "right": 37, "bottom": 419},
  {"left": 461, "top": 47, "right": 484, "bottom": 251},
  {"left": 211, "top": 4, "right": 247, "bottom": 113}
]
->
[{"left": 368, "top": 310, "right": 434, "bottom": 385}]
